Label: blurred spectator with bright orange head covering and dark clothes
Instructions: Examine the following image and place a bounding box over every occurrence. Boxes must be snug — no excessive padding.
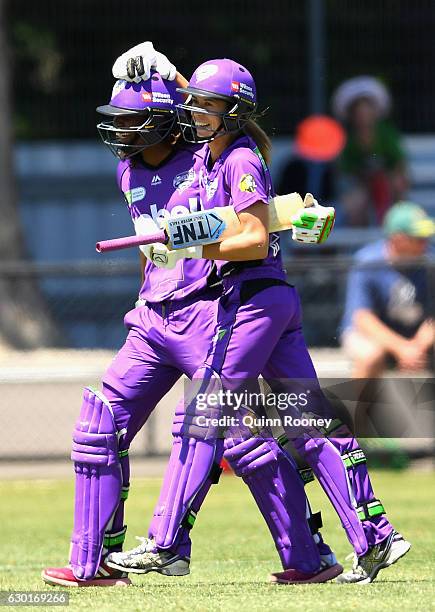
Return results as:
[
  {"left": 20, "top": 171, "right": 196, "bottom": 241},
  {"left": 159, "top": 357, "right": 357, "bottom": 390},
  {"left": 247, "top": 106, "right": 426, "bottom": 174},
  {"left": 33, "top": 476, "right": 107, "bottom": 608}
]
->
[{"left": 277, "top": 115, "right": 346, "bottom": 204}]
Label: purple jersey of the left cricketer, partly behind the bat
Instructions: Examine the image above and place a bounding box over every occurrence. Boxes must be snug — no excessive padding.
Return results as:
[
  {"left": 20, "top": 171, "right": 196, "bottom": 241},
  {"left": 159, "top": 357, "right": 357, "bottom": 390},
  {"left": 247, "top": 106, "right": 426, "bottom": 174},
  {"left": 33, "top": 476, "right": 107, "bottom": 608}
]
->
[{"left": 117, "top": 146, "right": 213, "bottom": 302}]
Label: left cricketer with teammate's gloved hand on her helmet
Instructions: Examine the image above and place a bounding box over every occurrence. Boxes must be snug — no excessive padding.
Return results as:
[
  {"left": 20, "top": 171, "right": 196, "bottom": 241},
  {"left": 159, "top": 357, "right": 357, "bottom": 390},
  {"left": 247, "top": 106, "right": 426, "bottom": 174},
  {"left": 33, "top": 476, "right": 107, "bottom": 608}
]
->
[{"left": 43, "top": 67, "right": 340, "bottom": 586}]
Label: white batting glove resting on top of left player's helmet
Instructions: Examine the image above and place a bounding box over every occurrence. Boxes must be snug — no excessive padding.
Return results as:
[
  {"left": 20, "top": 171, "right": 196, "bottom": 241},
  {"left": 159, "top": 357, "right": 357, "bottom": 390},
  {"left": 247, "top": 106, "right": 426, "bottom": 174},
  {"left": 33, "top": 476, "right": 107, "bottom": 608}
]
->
[{"left": 112, "top": 41, "right": 177, "bottom": 83}]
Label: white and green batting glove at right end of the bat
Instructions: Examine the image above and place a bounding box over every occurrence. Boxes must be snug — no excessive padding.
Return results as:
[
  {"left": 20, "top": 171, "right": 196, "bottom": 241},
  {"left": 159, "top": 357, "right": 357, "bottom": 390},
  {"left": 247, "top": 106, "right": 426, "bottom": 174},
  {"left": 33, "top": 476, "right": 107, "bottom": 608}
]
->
[{"left": 292, "top": 193, "right": 335, "bottom": 244}]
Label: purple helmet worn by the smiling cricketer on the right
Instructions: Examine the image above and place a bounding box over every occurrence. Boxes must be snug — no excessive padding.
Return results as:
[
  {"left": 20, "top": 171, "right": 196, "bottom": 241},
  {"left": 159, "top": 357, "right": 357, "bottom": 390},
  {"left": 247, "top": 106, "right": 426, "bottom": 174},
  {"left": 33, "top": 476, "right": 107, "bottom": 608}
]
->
[{"left": 176, "top": 59, "right": 257, "bottom": 142}]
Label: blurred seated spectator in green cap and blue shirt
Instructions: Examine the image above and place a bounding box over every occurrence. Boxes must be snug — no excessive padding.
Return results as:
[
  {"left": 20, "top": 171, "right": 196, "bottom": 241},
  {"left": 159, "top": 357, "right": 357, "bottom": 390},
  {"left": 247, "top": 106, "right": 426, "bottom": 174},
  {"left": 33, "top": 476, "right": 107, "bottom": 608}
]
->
[{"left": 341, "top": 202, "right": 435, "bottom": 378}]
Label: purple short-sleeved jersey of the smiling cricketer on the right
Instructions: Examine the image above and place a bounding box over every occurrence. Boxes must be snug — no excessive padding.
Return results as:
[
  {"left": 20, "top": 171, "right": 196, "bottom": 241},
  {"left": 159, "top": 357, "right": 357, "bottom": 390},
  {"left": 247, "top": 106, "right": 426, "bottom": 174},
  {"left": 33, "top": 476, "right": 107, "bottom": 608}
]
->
[{"left": 199, "top": 135, "right": 285, "bottom": 279}]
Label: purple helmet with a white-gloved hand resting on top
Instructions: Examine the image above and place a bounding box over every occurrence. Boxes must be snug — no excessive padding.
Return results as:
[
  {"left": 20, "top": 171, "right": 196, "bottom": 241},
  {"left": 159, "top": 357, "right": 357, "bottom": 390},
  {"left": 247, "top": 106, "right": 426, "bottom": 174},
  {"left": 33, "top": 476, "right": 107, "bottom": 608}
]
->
[{"left": 97, "top": 72, "right": 183, "bottom": 159}]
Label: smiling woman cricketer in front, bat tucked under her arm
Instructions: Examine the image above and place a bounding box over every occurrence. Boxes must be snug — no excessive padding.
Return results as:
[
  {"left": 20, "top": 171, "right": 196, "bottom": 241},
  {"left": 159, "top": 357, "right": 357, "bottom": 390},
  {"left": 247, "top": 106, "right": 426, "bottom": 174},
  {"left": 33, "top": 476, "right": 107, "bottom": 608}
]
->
[{"left": 109, "top": 46, "right": 410, "bottom": 582}]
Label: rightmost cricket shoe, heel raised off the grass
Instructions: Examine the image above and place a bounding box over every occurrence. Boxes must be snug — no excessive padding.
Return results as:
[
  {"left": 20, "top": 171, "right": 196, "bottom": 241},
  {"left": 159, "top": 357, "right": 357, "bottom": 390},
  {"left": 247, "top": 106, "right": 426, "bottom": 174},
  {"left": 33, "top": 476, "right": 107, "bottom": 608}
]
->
[{"left": 336, "top": 530, "right": 411, "bottom": 584}]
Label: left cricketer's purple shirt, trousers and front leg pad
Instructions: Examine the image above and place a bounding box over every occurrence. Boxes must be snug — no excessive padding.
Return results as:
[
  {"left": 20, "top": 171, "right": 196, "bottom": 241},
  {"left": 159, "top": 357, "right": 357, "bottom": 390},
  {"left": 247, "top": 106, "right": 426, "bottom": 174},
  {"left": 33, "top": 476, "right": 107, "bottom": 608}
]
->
[{"left": 70, "top": 146, "right": 221, "bottom": 579}]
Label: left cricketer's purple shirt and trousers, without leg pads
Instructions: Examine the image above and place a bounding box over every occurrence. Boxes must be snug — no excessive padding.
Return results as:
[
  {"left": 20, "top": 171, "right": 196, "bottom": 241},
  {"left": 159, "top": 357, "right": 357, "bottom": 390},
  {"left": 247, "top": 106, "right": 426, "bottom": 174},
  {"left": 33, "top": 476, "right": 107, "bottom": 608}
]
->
[{"left": 103, "top": 146, "right": 219, "bottom": 446}]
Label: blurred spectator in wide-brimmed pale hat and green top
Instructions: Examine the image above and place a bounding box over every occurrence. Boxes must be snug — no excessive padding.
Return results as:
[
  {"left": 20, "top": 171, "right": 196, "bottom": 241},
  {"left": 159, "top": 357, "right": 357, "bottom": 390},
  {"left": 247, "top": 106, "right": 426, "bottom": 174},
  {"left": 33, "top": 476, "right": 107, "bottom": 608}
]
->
[{"left": 332, "top": 76, "right": 408, "bottom": 226}]
